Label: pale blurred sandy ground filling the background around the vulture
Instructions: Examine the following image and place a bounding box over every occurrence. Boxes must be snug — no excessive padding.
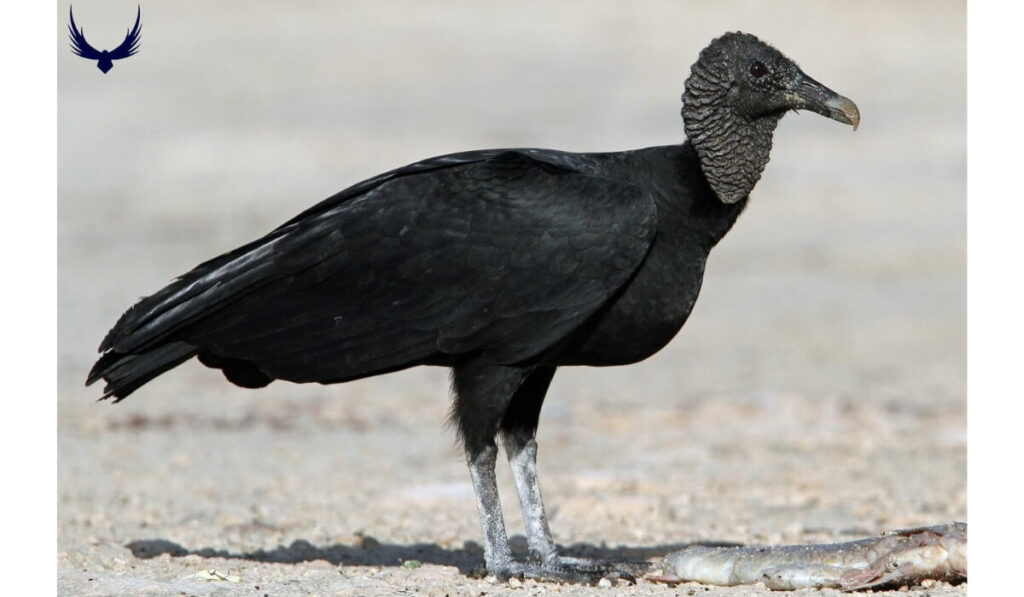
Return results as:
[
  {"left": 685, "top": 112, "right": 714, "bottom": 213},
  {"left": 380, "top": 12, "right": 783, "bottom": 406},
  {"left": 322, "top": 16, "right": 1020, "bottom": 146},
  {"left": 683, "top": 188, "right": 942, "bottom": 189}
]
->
[{"left": 56, "top": 0, "right": 967, "bottom": 596}]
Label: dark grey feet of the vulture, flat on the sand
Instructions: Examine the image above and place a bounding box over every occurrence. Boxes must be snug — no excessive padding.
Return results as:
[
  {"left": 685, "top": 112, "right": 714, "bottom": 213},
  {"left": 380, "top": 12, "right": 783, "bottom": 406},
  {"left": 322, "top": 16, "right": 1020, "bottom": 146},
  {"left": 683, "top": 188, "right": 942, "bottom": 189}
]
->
[{"left": 488, "top": 555, "right": 647, "bottom": 585}]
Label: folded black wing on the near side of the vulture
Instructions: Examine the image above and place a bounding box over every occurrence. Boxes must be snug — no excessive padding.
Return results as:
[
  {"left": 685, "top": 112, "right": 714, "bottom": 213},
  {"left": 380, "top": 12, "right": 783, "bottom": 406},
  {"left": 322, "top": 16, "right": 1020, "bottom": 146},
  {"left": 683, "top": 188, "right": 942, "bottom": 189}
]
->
[{"left": 94, "top": 151, "right": 656, "bottom": 381}]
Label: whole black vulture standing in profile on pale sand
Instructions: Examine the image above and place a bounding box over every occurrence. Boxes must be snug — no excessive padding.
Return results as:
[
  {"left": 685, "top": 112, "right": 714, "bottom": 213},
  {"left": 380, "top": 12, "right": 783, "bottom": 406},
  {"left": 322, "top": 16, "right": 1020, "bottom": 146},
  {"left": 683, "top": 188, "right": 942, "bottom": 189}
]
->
[{"left": 87, "top": 33, "right": 860, "bottom": 581}]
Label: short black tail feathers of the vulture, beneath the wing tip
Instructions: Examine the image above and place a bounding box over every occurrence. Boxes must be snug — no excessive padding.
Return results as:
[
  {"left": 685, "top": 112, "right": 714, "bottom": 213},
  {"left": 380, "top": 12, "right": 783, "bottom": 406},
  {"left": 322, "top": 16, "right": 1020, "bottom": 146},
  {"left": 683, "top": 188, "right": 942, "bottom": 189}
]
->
[{"left": 85, "top": 342, "right": 198, "bottom": 402}]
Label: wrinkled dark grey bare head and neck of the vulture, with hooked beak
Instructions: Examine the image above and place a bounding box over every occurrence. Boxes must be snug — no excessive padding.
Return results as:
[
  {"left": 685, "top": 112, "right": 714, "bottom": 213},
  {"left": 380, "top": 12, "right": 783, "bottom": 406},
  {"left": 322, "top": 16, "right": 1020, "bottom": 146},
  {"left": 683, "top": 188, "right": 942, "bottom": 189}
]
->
[{"left": 682, "top": 32, "right": 860, "bottom": 203}]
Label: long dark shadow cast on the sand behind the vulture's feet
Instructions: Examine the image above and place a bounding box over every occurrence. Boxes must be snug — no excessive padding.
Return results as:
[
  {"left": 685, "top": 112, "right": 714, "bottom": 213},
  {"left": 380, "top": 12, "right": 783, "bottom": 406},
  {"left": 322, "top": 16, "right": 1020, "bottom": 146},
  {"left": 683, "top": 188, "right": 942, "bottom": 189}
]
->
[{"left": 125, "top": 536, "right": 739, "bottom": 575}]
